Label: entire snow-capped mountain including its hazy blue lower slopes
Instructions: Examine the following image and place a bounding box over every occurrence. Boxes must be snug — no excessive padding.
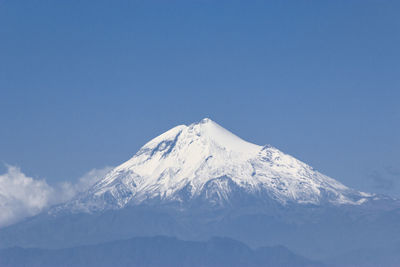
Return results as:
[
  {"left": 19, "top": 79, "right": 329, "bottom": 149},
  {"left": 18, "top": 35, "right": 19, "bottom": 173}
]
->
[{"left": 0, "top": 119, "right": 400, "bottom": 266}]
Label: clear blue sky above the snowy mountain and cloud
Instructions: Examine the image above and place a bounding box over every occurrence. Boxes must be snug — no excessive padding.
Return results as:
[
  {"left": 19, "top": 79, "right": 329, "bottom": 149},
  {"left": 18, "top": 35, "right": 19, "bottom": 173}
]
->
[{"left": 0, "top": 0, "right": 400, "bottom": 196}]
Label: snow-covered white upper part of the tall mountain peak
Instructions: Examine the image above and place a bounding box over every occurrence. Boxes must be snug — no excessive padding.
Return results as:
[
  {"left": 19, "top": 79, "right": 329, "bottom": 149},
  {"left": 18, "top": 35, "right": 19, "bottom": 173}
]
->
[{"left": 57, "top": 119, "right": 373, "bottom": 214}]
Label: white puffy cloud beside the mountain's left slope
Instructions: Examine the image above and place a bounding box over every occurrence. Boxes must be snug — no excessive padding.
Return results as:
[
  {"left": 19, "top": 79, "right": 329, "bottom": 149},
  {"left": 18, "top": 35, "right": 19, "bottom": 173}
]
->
[{"left": 0, "top": 166, "right": 112, "bottom": 227}]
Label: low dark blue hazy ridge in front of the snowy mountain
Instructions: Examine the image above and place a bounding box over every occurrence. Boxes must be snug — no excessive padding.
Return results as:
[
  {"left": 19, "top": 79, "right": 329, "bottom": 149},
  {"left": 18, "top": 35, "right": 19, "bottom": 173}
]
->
[{"left": 0, "top": 236, "right": 323, "bottom": 267}]
